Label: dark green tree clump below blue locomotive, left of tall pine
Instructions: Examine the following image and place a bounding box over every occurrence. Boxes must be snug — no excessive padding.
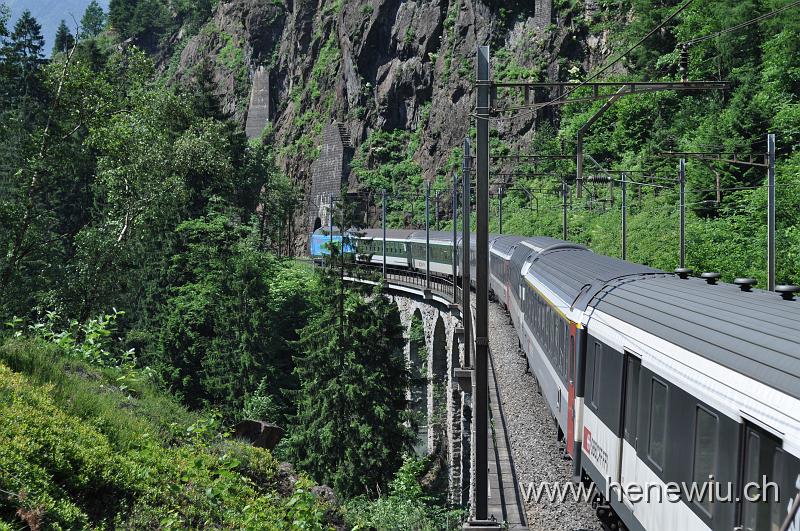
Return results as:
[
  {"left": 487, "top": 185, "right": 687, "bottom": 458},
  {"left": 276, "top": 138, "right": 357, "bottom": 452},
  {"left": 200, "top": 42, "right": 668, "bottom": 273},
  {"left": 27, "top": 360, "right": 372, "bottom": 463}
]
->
[{"left": 160, "top": 208, "right": 314, "bottom": 415}]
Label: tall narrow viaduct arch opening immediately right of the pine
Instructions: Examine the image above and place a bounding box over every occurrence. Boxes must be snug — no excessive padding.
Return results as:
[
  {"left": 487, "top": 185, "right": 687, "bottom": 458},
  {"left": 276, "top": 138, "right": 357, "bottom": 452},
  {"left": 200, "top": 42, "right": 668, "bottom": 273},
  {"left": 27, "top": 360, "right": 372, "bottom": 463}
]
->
[{"left": 407, "top": 308, "right": 428, "bottom": 455}]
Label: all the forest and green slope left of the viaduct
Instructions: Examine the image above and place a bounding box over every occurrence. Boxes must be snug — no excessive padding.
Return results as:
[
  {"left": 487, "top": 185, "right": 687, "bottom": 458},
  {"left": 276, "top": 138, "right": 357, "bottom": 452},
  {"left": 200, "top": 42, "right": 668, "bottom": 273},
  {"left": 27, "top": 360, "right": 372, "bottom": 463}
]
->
[{"left": 0, "top": 3, "right": 457, "bottom": 530}]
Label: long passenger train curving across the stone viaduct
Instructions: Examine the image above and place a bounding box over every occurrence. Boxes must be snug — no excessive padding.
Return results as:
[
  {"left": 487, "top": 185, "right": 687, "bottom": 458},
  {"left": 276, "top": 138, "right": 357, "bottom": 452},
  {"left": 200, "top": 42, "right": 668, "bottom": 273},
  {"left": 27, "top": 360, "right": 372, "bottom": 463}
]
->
[{"left": 311, "top": 225, "right": 800, "bottom": 531}]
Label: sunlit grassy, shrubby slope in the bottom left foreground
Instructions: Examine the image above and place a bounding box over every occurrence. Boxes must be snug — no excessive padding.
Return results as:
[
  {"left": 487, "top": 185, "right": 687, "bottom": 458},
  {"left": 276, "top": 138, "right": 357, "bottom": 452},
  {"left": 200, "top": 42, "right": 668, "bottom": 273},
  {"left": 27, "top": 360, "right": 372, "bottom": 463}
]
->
[{"left": 0, "top": 338, "right": 328, "bottom": 531}]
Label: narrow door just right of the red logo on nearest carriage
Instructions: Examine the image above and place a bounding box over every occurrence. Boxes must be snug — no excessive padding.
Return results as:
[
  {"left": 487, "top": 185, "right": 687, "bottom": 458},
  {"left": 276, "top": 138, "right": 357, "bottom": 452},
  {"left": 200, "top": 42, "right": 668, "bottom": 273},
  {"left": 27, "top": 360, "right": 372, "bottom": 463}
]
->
[{"left": 619, "top": 352, "right": 642, "bottom": 512}]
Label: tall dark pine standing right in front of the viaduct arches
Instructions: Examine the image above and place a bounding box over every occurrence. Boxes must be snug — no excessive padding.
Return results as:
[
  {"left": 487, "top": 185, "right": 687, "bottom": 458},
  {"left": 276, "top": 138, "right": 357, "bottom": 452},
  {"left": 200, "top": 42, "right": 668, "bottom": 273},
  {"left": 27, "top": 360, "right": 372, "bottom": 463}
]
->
[{"left": 289, "top": 278, "right": 414, "bottom": 496}]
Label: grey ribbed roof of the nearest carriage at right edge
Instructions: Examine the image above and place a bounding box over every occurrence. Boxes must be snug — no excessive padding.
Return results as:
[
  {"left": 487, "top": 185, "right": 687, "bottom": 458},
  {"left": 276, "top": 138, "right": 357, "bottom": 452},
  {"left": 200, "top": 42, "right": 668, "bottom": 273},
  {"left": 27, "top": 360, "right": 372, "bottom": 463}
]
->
[{"left": 592, "top": 275, "right": 800, "bottom": 399}]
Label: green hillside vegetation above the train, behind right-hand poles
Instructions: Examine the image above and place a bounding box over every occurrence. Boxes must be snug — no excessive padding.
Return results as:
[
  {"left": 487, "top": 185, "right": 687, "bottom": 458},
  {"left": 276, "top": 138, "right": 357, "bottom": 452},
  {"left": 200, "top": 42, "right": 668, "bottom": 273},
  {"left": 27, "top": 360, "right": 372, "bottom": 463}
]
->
[{"left": 476, "top": 0, "right": 800, "bottom": 287}]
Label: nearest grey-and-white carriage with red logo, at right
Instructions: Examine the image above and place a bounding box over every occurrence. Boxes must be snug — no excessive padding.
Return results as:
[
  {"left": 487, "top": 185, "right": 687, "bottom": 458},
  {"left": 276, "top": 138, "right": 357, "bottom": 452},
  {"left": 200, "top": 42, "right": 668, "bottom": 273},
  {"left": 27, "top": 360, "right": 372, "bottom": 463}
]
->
[{"left": 583, "top": 274, "right": 800, "bottom": 531}]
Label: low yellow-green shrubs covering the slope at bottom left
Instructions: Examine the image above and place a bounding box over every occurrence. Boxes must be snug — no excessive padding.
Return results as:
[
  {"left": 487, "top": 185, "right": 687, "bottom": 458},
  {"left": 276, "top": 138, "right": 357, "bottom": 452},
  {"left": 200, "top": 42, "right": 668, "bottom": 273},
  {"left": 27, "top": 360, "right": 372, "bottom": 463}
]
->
[{"left": 0, "top": 342, "right": 334, "bottom": 529}]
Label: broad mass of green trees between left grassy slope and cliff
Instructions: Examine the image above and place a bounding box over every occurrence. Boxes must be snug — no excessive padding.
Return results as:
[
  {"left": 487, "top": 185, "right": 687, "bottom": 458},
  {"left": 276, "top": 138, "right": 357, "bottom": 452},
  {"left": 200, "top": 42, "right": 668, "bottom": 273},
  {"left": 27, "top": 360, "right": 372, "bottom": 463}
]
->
[{"left": 0, "top": 26, "right": 314, "bottom": 436}]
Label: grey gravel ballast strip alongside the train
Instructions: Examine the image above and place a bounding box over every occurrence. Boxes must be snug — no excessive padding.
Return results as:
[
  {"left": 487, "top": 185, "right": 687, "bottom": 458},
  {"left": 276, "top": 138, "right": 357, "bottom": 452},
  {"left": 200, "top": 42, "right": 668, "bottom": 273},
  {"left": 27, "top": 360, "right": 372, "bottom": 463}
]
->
[{"left": 489, "top": 304, "right": 601, "bottom": 531}]
